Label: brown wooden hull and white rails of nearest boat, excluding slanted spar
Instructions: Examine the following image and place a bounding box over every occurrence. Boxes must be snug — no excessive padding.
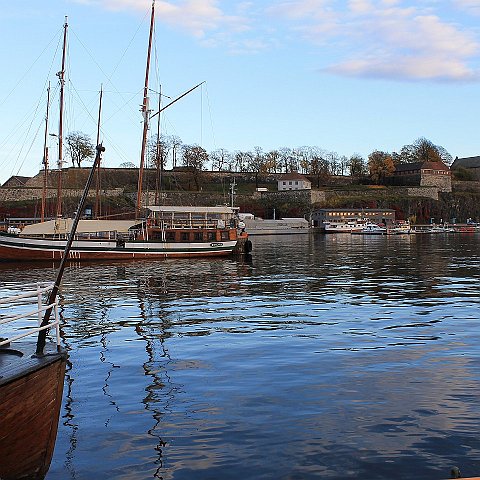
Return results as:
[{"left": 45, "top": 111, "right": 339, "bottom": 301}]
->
[{"left": 0, "top": 285, "right": 66, "bottom": 480}]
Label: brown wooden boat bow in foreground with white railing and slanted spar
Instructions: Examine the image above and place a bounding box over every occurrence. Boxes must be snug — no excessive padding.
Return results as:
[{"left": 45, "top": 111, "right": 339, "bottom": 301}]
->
[{"left": 0, "top": 146, "right": 103, "bottom": 480}]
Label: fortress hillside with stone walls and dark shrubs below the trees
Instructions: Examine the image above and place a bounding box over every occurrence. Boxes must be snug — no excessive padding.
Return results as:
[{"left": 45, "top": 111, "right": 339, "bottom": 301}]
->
[{"left": 0, "top": 168, "right": 480, "bottom": 222}]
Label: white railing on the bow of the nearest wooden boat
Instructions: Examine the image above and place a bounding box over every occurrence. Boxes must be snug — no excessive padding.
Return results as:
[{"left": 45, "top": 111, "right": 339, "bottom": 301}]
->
[{"left": 0, "top": 282, "right": 60, "bottom": 347}]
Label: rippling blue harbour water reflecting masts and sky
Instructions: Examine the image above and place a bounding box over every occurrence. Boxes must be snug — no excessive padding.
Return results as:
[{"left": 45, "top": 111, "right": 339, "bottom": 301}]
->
[{"left": 0, "top": 234, "right": 480, "bottom": 480}]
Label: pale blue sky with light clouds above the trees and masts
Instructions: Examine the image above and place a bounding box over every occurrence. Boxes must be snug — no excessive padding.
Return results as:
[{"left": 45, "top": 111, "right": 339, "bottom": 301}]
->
[{"left": 0, "top": 0, "right": 480, "bottom": 184}]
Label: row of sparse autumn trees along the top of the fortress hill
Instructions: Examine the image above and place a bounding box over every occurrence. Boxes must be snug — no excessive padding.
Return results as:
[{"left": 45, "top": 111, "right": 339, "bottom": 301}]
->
[{"left": 62, "top": 132, "right": 452, "bottom": 184}]
